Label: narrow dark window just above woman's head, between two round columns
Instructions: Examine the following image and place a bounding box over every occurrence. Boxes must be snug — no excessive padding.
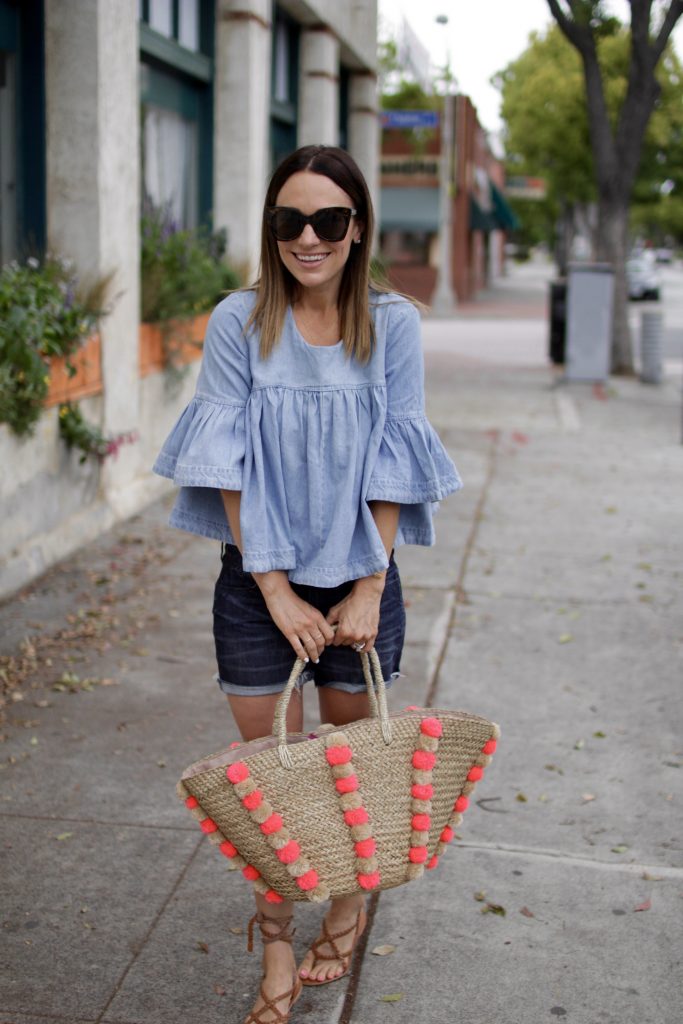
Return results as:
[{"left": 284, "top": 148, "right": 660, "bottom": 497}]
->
[{"left": 270, "top": 7, "right": 299, "bottom": 168}]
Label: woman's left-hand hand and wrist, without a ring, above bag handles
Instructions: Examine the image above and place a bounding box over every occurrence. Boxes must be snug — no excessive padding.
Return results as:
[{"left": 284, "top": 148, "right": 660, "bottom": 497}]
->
[{"left": 252, "top": 570, "right": 335, "bottom": 662}]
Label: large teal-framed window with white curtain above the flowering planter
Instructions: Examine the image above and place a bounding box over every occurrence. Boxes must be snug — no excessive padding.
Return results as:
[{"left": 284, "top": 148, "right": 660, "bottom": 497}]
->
[{"left": 139, "top": 0, "right": 214, "bottom": 228}]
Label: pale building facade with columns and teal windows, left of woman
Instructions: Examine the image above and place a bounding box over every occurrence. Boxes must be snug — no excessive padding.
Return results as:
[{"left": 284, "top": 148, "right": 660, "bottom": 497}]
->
[{"left": 0, "top": 0, "right": 378, "bottom": 595}]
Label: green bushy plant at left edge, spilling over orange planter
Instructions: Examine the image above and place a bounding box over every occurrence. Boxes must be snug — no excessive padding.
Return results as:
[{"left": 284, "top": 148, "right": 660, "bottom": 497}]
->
[{"left": 0, "top": 258, "right": 105, "bottom": 436}]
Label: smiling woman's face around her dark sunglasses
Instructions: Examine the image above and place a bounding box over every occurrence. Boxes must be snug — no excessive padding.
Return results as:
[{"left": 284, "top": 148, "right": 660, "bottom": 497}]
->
[{"left": 275, "top": 171, "right": 361, "bottom": 299}]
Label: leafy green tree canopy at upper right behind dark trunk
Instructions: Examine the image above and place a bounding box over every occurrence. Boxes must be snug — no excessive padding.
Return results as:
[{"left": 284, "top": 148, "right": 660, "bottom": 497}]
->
[{"left": 494, "top": 25, "right": 683, "bottom": 225}]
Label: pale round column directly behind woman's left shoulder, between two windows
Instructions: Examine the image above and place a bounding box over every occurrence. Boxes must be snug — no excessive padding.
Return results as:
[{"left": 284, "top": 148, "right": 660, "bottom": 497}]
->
[{"left": 218, "top": 0, "right": 271, "bottom": 280}]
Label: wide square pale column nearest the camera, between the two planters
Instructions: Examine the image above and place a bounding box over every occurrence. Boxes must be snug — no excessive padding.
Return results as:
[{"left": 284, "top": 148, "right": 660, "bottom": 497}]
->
[{"left": 45, "top": 0, "right": 139, "bottom": 502}]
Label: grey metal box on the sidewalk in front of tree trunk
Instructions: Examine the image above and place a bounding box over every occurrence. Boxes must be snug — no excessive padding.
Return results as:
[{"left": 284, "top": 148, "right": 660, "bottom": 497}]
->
[{"left": 564, "top": 263, "right": 614, "bottom": 381}]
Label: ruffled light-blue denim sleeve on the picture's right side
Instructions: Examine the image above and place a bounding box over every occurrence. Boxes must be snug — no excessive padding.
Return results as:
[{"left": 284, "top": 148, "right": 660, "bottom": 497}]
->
[{"left": 366, "top": 302, "right": 462, "bottom": 505}]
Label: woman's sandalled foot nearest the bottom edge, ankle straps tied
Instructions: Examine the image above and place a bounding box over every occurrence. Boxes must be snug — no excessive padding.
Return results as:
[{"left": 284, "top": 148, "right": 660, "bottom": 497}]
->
[{"left": 244, "top": 914, "right": 301, "bottom": 1024}]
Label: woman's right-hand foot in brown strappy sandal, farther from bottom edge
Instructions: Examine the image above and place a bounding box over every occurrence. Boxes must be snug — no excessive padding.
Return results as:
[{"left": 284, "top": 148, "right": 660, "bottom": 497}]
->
[{"left": 299, "top": 896, "right": 367, "bottom": 985}]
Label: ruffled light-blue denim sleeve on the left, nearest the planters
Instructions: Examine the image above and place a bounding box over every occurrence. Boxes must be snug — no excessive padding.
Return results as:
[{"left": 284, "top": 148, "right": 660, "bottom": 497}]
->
[{"left": 153, "top": 296, "right": 251, "bottom": 490}]
